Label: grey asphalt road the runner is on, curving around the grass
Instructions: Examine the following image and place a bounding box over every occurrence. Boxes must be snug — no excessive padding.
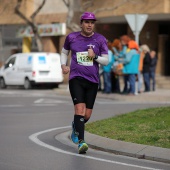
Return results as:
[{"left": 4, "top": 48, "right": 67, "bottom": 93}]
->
[{"left": 0, "top": 88, "right": 170, "bottom": 170}]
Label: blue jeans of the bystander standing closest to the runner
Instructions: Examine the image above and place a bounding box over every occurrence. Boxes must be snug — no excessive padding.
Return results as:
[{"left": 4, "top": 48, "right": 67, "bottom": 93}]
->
[{"left": 103, "top": 72, "right": 112, "bottom": 93}]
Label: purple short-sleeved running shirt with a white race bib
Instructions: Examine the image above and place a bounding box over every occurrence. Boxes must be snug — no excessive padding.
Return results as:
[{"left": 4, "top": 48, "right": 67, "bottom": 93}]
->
[{"left": 64, "top": 32, "right": 108, "bottom": 83}]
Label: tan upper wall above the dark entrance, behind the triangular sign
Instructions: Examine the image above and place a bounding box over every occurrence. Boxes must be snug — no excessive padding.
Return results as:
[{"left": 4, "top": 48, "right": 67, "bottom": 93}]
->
[{"left": 87, "top": 0, "right": 170, "bottom": 17}]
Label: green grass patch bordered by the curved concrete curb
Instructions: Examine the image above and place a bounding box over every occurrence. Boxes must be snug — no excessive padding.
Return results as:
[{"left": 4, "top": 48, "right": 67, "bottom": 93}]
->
[{"left": 86, "top": 107, "right": 170, "bottom": 148}]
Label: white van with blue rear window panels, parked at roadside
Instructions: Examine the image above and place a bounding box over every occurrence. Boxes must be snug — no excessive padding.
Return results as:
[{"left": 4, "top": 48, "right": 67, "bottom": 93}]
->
[{"left": 0, "top": 52, "right": 63, "bottom": 89}]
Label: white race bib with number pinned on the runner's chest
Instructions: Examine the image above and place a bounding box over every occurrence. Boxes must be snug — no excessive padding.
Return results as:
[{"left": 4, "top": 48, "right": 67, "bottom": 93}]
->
[{"left": 76, "top": 51, "right": 93, "bottom": 66}]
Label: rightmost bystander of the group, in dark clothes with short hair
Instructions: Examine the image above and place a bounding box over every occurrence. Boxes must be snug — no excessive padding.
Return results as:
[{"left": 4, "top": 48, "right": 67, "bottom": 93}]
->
[{"left": 149, "top": 50, "right": 158, "bottom": 91}]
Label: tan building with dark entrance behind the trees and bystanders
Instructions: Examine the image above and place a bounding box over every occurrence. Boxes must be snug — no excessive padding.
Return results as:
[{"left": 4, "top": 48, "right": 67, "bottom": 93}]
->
[{"left": 0, "top": 0, "right": 170, "bottom": 76}]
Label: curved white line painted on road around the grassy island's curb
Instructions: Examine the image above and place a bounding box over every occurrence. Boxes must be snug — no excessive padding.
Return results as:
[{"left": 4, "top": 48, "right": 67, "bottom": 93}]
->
[{"left": 29, "top": 126, "right": 160, "bottom": 170}]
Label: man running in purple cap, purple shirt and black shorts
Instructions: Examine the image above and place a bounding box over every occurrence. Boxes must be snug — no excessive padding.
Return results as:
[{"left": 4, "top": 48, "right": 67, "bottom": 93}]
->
[{"left": 60, "top": 12, "right": 108, "bottom": 154}]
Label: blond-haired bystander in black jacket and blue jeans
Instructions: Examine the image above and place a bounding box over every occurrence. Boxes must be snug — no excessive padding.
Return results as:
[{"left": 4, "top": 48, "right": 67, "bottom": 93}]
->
[{"left": 141, "top": 44, "right": 151, "bottom": 92}]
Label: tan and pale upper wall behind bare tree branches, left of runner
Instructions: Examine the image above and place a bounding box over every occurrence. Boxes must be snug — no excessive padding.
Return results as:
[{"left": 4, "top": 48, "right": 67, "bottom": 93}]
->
[{"left": 0, "top": 0, "right": 67, "bottom": 25}]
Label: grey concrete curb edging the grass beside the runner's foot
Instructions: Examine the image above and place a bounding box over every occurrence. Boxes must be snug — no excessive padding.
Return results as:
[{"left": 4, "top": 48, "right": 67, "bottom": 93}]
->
[{"left": 85, "top": 132, "right": 170, "bottom": 163}]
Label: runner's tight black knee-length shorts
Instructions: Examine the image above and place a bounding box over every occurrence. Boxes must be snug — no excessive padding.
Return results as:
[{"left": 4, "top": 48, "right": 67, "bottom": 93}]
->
[{"left": 69, "top": 77, "right": 98, "bottom": 109}]
